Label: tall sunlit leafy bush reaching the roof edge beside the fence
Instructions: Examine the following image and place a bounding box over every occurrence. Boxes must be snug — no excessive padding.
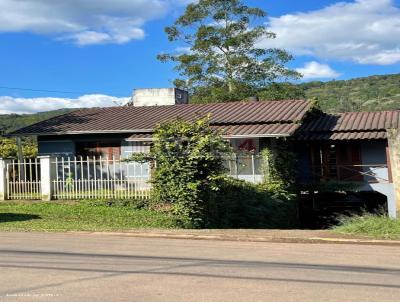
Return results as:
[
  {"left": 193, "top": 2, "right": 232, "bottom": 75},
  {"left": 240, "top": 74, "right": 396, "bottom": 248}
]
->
[{"left": 129, "top": 118, "right": 230, "bottom": 227}]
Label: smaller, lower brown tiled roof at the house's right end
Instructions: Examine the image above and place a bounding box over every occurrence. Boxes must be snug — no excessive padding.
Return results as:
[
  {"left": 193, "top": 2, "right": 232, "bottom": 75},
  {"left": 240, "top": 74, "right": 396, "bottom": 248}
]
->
[{"left": 296, "top": 110, "right": 400, "bottom": 140}]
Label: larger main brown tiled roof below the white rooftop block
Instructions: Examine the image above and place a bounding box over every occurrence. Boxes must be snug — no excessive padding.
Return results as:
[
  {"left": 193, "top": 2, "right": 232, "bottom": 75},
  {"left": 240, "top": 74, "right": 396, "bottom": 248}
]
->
[{"left": 11, "top": 100, "right": 310, "bottom": 136}]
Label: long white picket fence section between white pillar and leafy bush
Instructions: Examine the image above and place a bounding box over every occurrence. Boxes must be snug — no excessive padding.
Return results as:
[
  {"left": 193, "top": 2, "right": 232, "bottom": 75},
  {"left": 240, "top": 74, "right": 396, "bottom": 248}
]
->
[{"left": 51, "top": 157, "right": 151, "bottom": 200}]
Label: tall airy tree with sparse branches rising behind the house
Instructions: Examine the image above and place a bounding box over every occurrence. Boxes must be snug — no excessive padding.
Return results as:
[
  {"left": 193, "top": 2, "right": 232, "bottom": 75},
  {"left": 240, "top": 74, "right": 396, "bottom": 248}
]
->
[{"left": 158, "top": 0, "right": 300, "bottom": 102}]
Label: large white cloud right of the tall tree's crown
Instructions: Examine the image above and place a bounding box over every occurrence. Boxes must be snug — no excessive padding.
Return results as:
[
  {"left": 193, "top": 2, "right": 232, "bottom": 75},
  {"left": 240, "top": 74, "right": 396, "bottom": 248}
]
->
[{"left": 260, "top": 0, "right": 400, "bottom": 65}]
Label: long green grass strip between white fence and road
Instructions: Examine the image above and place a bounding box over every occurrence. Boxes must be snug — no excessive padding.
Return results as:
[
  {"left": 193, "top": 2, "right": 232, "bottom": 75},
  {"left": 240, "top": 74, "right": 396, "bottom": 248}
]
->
[{"left": 0, "top": 201, "right": 178, "bottom": 231}]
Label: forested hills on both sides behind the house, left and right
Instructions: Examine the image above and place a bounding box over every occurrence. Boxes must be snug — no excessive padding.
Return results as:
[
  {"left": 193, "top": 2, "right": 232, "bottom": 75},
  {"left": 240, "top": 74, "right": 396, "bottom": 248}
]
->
[{"left": 0, "top": 74, "right": 400, "bottom": 132}]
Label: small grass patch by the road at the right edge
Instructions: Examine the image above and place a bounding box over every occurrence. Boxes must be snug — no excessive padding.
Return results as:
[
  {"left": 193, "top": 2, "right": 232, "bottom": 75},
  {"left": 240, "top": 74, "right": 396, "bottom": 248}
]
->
[{"left": 333, "top": 214, "right": 400, "bottom": 239}]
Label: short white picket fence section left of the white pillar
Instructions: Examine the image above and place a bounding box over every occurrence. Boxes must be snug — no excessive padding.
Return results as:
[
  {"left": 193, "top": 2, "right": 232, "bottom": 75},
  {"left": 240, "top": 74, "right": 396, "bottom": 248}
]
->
[{"left": 6, "top": 158, "right": 42, "bottom": 200}]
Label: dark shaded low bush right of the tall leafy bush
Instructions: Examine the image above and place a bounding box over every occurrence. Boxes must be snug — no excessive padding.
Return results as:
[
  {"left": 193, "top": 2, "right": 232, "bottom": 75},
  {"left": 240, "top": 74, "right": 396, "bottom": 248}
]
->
[{"left": 204, "top": 178, "right": 298, "bottom": 228}]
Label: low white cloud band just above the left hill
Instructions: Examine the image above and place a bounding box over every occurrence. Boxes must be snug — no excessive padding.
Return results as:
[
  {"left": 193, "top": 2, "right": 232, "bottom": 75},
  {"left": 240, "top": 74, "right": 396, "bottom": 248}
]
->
[{"left": 0, "top": 94, "right": 130, "bottom": 114}]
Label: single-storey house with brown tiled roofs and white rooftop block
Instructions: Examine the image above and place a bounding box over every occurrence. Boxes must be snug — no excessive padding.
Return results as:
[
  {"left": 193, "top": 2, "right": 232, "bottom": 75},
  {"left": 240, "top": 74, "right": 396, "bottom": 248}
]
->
[{"left": 12, "top": 89, "right": 400, "bottom": 216}]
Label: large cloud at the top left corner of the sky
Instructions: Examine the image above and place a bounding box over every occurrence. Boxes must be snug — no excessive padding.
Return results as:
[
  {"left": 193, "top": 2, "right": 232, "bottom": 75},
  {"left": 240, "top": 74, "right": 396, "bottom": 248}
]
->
[{"left": 0, "top": 0, "right": 172, "bottom": 45}]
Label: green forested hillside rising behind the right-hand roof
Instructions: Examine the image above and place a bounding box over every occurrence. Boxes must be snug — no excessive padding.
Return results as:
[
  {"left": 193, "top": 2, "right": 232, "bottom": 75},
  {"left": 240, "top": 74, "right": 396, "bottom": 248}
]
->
[{"left": 298, "top": 74, "right": 400, "bottom": 112}]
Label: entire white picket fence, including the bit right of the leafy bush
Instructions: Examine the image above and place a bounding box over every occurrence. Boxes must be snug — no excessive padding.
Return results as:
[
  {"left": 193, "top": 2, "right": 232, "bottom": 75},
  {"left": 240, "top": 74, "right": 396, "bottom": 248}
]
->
[{"left": 0, "top": 155, "right": 263, "bottom": 200}]
